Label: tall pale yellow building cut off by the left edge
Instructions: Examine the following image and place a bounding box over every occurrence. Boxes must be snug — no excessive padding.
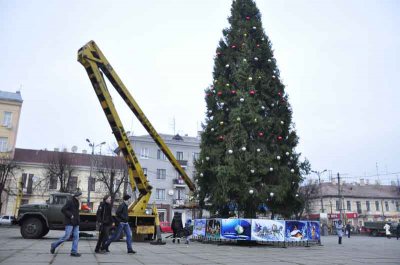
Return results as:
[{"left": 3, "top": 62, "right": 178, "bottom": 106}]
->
[{"left": 0, "top": 91, "right": 23, "bottom": 158}]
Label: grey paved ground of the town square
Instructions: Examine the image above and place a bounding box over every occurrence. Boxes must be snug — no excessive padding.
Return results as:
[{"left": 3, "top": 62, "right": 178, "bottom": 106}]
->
[{"left": 0, "top": 227, "right": 400, "bottom": 265}]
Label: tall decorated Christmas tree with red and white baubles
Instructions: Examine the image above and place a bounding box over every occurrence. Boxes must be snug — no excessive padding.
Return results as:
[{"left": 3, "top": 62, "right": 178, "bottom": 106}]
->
[{"left": 195, "top": 0, "right": 309, "bottom": 217}]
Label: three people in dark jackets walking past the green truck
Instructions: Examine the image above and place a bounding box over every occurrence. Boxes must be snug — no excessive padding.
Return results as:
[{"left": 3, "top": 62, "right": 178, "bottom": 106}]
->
[{"left": 50, "top": 192, "right": 136, "bottom": 257}]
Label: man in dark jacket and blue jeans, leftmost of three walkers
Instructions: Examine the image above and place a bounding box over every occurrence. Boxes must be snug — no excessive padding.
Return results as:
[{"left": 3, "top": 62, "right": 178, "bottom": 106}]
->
[{"left": 50, "top": 191, "right": 82, "bottom": 257}]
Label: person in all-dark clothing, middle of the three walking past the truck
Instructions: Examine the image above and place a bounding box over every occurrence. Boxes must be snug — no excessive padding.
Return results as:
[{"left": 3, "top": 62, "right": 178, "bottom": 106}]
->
[{"left": 94, "top": 195, "right": 113, "bottom": 253}]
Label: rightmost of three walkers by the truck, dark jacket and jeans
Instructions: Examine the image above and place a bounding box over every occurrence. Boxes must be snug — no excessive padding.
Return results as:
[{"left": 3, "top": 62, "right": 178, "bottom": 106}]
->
[{"left": 104, "top": 195, "right": 136, "bottom": 254}]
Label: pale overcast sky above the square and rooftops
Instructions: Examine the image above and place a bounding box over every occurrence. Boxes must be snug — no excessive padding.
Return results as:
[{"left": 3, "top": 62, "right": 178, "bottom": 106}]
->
[{"left": 0, "top": 0, "right": 400, "bottom": 181}]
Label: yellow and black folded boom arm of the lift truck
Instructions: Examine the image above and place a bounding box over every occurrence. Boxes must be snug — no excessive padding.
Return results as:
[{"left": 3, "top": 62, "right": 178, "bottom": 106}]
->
[{"left": 78, "top": 41, "right": 195, "bottom": 214}]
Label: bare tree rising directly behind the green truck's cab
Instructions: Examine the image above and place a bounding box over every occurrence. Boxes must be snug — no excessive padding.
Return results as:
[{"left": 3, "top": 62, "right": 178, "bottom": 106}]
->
[{"left": 44, "top": 152, "right": 76, "bottom": 192}]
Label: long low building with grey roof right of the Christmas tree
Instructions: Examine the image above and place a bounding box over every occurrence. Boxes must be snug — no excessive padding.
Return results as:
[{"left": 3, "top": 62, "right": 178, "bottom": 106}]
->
[{"left": 308, "top": 180, "right": 400, "bottom": 227}]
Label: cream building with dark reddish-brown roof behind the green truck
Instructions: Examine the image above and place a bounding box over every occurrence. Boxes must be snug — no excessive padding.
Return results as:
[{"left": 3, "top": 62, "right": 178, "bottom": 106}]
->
[{"left": 1, "top": 148, "right": 127, "bottom": 215}]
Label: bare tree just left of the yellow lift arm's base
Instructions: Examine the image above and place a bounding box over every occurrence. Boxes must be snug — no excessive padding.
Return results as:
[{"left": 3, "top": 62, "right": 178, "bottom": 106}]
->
[{"left": 94, "top": 156, "right": 128, "bottom": 204}]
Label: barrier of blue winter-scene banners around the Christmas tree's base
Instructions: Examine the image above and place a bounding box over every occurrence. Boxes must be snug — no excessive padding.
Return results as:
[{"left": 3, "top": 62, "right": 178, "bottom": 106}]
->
[{"left": 192, "top": 218, "right": 321, "bottom": 245}]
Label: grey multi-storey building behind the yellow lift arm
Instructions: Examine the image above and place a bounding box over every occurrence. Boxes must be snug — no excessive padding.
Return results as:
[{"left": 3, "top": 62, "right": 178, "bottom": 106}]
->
[{"left": 129, "top": 134, "right": 200, "bottom": 221}]
